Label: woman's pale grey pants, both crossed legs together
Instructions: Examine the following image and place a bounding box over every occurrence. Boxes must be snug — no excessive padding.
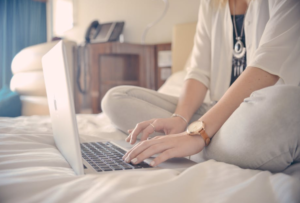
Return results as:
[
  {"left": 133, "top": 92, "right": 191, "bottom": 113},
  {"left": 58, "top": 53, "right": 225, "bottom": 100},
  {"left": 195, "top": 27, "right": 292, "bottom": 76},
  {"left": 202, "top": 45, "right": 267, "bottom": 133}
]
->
[{"left": 102, "top": 85, "right": 300, "bottom": 172}]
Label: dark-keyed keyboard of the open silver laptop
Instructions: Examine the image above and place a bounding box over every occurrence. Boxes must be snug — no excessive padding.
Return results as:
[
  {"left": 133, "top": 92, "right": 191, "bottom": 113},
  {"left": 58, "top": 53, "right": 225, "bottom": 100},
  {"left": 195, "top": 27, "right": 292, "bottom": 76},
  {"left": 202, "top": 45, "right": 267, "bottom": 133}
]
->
[{"left": 80, "top": 142, "right": 151, "bottom": 172}]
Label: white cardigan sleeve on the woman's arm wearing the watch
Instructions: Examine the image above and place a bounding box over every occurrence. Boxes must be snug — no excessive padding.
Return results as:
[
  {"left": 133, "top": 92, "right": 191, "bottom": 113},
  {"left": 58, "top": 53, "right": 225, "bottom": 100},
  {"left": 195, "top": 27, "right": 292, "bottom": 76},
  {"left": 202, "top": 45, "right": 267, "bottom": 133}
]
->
[{"left": 248, "top": 0, "right": 300, "bottom": 85}]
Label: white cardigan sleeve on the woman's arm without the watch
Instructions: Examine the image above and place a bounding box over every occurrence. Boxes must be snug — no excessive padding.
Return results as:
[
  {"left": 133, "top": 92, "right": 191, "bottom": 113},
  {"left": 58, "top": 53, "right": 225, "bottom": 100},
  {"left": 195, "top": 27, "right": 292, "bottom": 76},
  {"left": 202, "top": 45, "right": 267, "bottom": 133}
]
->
[{"left": 185, "top": 0, "right": 211, "bottom": 88}]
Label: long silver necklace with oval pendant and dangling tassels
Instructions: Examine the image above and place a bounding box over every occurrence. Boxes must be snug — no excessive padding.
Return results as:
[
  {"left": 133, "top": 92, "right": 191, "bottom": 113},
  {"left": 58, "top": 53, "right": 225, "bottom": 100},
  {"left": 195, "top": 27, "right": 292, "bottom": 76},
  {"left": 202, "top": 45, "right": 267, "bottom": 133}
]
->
[{"left": 233, "top": 1, "right": 246, "bottom": 76}]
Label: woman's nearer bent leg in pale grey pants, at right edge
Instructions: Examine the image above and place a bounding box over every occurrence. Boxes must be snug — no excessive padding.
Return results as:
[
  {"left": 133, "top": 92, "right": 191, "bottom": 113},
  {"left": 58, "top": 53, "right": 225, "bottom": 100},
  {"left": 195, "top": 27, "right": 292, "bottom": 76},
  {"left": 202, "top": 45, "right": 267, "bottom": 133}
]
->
[{"left": 204, "top": 85, "right": 300, "bottom": 172}]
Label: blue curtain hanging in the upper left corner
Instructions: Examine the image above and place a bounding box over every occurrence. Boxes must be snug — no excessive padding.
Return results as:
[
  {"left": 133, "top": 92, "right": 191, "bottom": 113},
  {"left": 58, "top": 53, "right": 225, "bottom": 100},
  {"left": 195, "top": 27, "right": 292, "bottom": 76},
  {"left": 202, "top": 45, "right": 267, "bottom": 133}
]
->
[{"left": 0, "top": 0, "right": 47, "bottom": 89}]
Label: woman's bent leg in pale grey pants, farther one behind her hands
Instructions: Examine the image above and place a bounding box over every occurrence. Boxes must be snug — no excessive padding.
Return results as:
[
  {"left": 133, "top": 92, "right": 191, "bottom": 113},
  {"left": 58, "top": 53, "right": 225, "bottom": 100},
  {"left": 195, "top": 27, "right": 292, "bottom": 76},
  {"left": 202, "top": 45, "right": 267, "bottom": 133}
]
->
[{"left": 101, "top": 86, "right": 210, "bottom": 133}]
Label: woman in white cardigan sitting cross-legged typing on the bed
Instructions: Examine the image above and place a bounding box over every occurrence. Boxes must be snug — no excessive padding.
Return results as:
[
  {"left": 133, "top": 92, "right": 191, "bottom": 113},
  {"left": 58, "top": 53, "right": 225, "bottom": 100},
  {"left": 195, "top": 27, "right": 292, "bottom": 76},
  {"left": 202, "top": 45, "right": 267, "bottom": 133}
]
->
[{"left": 102, "top": 0, "right": 300, "bottom": 172}]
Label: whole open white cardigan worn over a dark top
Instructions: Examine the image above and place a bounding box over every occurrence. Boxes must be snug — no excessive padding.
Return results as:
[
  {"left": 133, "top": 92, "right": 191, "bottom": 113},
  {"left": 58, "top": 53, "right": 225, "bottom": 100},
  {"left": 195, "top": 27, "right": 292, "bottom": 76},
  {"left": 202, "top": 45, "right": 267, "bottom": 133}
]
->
[{"left": 185, "top": 0, "right": 300, "bottom": 101}]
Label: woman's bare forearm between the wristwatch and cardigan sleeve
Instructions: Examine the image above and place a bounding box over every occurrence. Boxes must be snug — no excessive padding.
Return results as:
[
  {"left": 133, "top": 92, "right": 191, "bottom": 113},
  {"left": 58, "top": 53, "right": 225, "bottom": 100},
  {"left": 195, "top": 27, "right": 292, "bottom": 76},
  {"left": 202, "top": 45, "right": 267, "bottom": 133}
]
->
[{"left": 199, "top": 67, "right": 279, "bottom": 137}]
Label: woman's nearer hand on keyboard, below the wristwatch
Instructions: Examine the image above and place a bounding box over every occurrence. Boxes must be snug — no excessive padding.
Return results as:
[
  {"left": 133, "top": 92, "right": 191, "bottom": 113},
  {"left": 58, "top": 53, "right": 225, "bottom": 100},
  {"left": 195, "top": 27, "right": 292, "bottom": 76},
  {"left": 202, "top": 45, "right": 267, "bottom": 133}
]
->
[{"left": 123, "top": 132, "right": 205, "bottom": 166}]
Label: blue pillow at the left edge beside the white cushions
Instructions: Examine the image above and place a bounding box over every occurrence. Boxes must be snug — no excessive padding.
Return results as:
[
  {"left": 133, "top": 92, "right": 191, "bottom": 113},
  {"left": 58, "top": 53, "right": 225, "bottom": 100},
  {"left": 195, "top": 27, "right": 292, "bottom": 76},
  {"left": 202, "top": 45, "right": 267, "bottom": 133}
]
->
[{"left": 0, "top": 86, "right": 22, "bottom": 117}]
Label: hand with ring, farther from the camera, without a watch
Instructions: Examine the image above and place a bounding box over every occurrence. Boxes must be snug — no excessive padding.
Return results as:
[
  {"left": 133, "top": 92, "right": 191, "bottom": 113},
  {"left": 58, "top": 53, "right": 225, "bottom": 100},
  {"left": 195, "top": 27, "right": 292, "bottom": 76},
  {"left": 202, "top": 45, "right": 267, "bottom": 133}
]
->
[{"left": 125, "top": 117, "right": 187, "bottom": 144}]
